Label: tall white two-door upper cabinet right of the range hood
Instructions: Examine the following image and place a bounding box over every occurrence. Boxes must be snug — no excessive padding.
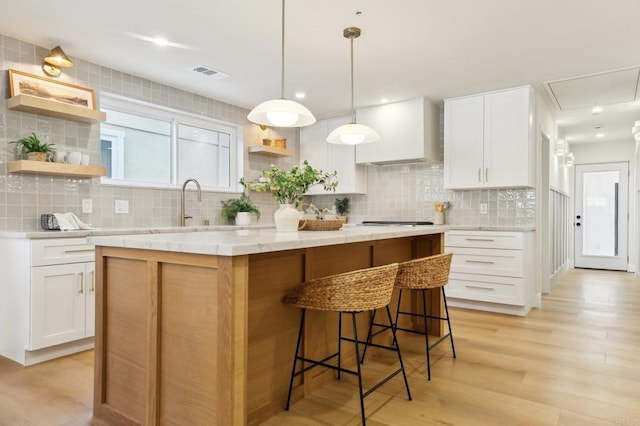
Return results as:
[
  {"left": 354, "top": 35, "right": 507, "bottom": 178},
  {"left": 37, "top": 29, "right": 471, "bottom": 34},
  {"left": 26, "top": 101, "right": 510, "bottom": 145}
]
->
[{"left": 444, "top": 86, "right": 535, "bottom": 189}]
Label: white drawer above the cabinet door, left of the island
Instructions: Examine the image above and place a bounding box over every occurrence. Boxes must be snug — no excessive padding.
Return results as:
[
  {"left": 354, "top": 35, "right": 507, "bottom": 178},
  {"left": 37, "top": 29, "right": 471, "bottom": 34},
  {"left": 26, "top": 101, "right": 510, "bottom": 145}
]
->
[{"left": 31, "top": 237, "right": 95, "bottom": 266}]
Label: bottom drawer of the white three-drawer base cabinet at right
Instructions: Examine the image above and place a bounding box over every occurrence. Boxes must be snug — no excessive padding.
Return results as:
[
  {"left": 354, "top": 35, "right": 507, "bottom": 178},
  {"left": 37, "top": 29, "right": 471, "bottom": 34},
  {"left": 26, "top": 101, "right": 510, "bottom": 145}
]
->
[{"left": 445, "top": 273, "right": 525, "bottom": 306}]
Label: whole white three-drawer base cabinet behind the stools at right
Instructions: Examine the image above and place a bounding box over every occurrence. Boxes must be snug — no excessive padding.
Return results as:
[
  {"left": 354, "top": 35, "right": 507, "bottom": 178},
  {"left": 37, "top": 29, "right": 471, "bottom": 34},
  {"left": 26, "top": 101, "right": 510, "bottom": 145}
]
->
[{"left": 445, "top": 230, "right": 540, "bottom": 315}]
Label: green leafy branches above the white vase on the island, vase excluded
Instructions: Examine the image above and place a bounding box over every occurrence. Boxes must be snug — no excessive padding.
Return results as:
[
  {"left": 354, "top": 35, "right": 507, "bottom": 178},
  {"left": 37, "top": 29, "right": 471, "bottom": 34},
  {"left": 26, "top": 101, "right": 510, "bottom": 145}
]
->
[{"left": 250, "top": 160, "right": 338, "bottom": 207}]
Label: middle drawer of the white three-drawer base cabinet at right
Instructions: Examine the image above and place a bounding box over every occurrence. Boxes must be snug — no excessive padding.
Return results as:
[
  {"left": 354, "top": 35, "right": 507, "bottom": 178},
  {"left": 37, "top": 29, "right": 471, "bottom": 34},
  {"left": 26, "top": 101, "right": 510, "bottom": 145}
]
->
[{"left": 445, "top": 247, "right": 524, "bottom": 278}]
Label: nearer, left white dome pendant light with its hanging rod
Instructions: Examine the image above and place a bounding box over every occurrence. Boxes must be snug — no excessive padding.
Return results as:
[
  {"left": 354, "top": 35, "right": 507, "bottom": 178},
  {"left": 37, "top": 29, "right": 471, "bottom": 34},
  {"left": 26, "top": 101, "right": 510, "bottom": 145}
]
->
[{"left": 247, "top": 0, "right": 316, "bottom": 127}]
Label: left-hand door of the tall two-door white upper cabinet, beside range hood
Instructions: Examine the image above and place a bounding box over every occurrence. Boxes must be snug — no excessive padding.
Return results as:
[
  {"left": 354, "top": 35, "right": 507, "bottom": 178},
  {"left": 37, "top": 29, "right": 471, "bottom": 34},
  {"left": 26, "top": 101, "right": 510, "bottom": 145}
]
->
[{"left": 444, "top": 96, "right": 484, "bottom": 189}]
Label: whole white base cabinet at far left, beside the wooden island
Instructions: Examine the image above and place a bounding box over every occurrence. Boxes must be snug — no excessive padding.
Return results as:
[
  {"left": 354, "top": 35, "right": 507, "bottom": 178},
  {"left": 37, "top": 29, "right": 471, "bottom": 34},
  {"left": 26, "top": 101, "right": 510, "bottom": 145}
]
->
[{"left": 0, "top": 237, "right": 95, "bottom": 365}]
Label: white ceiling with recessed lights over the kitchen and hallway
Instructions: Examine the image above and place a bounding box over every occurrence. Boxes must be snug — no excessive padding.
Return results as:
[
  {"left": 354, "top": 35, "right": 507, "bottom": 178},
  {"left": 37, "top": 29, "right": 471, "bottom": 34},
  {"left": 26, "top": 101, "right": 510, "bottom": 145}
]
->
[{"left": 0, "top": 0, "right": 640, "bottom": 146}]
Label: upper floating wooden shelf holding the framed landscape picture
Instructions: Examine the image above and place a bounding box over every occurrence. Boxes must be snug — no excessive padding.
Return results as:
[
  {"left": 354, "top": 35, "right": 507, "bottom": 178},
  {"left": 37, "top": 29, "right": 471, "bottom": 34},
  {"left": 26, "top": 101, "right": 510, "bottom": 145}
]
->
[{"left": 7, "top": 95, "right": 107, "bottom": 123}]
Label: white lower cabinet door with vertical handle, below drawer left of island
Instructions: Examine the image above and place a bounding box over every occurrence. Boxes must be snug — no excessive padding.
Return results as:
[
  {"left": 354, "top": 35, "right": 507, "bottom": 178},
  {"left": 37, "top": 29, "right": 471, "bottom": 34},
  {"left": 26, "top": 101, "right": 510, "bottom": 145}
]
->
[{"left": 29, "top": 263, "right": 86, "bottom": 350}]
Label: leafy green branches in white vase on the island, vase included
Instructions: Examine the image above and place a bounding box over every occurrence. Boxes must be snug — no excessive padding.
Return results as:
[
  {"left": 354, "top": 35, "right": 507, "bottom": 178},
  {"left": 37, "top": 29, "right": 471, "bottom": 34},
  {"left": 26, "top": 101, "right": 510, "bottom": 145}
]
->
[{"left": 251, "top": 160, "right": 338, "bottom": 231}]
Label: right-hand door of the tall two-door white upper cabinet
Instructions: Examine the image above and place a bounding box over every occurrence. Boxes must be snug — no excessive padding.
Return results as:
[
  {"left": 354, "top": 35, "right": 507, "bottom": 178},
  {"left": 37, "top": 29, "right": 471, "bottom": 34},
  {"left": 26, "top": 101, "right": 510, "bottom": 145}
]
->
[{"left": 484, "top": 87, "right": 534, "bottom": 187}]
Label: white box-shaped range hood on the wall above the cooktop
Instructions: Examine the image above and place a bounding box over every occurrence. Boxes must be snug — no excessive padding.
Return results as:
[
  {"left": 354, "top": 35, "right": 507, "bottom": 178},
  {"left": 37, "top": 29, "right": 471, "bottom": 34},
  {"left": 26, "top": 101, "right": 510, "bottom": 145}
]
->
[{"left": 356, "top": 98, "right": 440, "bottom": 164}]
